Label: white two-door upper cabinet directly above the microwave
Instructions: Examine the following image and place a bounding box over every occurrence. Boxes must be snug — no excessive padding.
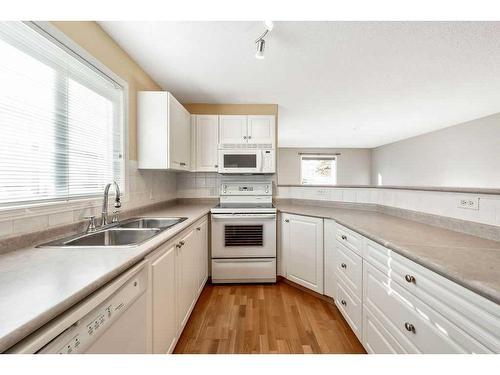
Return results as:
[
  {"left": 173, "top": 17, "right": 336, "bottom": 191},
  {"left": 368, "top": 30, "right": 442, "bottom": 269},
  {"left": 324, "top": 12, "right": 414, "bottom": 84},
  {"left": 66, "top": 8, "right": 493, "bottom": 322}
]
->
[{"left": 219, "top": 115, "right": 276, "bottom": 148}]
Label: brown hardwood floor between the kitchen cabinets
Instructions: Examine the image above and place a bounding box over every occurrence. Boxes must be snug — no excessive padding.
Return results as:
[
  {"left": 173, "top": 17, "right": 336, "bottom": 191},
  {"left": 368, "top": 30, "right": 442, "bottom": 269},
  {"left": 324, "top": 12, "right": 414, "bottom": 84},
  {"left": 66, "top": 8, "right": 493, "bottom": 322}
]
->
[{"left": 174, "top": 281, "right": 365, "bottom": 354}]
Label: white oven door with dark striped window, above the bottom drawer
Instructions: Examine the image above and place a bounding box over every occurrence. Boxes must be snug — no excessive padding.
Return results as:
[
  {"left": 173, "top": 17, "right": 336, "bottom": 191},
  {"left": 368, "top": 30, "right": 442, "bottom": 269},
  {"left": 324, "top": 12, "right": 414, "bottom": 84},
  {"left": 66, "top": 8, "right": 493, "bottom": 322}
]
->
[{"left": 212, "top": 214, "right": 276, "bottom": 258}]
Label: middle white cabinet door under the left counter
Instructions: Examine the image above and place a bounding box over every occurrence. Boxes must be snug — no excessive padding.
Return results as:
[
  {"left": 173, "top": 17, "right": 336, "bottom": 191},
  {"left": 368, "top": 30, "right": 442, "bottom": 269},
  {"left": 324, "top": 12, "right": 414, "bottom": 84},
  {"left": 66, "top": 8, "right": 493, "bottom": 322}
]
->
[{"left": 175, "top": 230, "right": 198, "bottom": 330}]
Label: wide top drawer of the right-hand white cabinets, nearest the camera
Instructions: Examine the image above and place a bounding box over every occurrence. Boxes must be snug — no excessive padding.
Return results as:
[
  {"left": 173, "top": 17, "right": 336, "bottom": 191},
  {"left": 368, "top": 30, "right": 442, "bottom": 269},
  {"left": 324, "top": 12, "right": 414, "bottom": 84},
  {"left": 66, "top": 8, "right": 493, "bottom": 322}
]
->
[{"left": 363, "top": 239, "right": 500, "bottom": 352}]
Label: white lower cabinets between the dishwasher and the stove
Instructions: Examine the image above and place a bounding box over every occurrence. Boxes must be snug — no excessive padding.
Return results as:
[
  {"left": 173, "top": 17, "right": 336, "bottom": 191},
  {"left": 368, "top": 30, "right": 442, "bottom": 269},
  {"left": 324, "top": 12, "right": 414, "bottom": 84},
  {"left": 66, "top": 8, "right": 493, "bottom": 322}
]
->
[{"left": 148, "top": 218, "right": 208, "bottom": 354}]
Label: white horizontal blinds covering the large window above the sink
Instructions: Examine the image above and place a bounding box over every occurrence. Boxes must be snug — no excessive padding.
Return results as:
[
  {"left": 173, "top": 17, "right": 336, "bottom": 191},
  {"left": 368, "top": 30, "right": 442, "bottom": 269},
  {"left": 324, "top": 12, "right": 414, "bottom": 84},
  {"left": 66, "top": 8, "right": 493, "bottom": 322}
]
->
[{"left": 0, "top": 22, "right": 124, "bottom": 206}]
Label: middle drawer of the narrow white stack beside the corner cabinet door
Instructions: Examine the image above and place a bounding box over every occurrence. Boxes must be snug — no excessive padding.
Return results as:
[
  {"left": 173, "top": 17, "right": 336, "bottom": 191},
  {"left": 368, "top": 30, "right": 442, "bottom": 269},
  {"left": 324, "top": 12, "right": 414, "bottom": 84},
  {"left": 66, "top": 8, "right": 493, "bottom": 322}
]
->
[{"left": 335, "top": 244, "right": 363, "bottom": 299}]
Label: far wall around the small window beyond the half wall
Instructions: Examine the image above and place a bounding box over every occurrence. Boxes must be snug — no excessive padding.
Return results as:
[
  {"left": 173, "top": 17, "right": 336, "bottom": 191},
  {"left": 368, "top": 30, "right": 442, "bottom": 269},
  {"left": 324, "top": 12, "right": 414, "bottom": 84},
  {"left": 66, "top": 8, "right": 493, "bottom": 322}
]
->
[{"left": 278, "top": 148, "right": 371, "bottom": 185}]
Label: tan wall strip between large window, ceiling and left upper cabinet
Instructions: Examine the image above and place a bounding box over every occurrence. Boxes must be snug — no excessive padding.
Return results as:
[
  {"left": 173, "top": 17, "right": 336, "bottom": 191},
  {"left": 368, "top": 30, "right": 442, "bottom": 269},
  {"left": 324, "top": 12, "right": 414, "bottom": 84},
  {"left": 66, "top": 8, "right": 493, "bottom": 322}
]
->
[{"left": 51, "top": 21, "right": 161, "bottom": 160}]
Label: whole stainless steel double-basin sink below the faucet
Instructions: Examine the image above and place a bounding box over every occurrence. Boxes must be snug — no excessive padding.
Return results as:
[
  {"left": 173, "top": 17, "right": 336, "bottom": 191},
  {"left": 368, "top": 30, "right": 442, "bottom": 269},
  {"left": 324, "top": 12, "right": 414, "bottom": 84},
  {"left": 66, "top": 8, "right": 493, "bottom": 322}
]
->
[{"left": 37, "top": 217, "right": 187, "bottom": 247}]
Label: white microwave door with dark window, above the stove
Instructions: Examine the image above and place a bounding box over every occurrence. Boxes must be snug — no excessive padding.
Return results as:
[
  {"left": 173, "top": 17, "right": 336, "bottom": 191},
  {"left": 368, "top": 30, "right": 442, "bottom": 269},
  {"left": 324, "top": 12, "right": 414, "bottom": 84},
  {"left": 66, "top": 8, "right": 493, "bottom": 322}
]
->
[{"left": 219, "top": 150, "right": 262, "bottom": 173}]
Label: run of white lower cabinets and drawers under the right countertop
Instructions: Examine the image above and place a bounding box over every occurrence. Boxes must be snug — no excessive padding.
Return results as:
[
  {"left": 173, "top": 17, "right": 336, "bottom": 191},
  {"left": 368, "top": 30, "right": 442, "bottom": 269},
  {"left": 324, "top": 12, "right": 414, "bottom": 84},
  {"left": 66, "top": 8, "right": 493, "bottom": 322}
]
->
[{"left": 316, "top": 215, "right": 500, "bottom": 353}]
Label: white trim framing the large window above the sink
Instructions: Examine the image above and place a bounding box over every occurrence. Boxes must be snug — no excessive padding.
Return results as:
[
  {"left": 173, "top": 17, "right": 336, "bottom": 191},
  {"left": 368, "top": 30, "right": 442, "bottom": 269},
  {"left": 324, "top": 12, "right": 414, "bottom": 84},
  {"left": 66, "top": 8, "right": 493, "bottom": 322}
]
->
[{"left": 0, "top": 21, "right": 130, "bottom": 219}]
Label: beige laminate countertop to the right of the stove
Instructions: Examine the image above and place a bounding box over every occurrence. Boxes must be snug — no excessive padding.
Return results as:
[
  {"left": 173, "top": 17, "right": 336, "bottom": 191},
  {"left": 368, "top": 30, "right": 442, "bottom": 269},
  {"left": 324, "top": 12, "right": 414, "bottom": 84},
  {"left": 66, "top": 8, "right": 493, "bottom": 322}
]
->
[{"left": 276, "top": 202, "right": 500, "bottom": 304}]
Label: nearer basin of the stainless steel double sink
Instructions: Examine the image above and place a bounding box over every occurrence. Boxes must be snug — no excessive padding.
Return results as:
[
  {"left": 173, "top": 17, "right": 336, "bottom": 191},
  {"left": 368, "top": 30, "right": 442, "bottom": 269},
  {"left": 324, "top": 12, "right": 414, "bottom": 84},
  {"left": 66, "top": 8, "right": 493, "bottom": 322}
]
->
[{"left": 38, "top": 228, "right": 161, "bottom": 247}]
